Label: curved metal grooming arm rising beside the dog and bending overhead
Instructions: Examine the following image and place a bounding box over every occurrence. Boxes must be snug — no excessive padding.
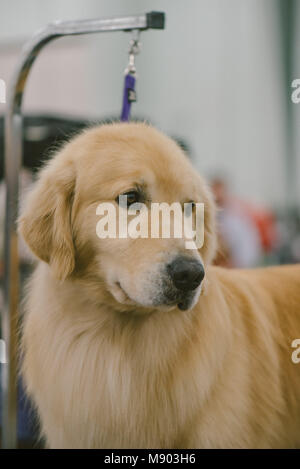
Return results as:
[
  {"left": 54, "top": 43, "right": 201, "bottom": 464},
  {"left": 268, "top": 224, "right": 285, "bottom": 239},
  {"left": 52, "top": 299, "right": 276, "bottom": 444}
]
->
[{"left": 1, "top": 12, "right": 164, "bottom": 448}]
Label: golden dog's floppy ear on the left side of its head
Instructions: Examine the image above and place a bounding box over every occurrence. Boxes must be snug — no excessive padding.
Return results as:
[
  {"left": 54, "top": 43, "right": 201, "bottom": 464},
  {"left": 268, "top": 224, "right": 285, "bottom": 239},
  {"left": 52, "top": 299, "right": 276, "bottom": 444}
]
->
[{"left": 19, "top": 155, "right": 75, "bottom": 280}]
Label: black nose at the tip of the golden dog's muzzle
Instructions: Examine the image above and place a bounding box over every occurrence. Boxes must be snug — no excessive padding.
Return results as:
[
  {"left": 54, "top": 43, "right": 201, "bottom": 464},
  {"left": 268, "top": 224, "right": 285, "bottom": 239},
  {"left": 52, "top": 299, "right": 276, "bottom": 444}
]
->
[{"left": 168, "top": 256, "right": 205, "bottom": 291}]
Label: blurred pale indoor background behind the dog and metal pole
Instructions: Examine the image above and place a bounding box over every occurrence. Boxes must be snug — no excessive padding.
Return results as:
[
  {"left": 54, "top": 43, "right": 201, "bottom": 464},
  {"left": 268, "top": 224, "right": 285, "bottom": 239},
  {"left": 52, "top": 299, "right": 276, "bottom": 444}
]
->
[{"left": 0, "top": 0, "right": 300, "bottom": 446}]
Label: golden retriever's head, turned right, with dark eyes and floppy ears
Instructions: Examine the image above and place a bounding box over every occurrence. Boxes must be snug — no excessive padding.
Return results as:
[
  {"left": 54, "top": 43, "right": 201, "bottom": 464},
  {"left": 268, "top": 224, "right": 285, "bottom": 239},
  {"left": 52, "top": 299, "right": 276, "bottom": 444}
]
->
[{"left": 19, "top": 123, "right": 216, "bottom": 311}]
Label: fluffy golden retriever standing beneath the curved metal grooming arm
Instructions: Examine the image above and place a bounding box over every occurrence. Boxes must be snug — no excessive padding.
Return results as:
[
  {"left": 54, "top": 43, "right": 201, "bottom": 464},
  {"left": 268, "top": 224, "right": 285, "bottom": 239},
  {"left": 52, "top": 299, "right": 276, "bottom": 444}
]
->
[{"left": 19, "top": 123, "right": 300, "bottom": 449}]
